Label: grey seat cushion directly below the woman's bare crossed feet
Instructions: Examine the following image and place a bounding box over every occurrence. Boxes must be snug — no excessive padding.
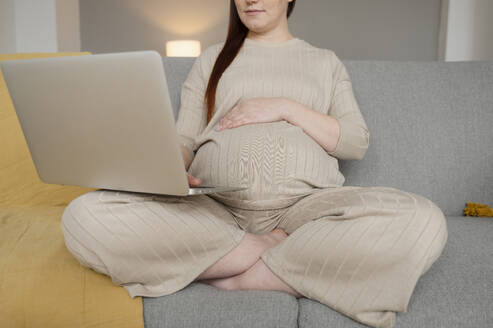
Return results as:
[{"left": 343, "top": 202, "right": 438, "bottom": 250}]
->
[{"left": 143, "top": 282, "right": 298, "bottom": 328}]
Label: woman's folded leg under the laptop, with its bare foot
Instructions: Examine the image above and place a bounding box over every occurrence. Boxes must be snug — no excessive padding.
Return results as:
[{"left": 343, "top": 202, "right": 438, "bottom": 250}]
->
[{"left": 62, "top": 190, "right": 295, "bottom": 297}]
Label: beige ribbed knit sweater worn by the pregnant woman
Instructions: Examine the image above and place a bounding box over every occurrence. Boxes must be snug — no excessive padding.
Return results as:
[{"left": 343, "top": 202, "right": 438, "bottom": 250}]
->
[{"left": 176, "top": 38, "right": 369, "bottom": 209}]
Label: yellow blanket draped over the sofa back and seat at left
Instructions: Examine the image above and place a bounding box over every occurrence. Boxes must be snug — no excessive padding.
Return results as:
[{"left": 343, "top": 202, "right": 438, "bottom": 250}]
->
[{"left": 0, "top": 53, "right": 144, "bottom": 328}]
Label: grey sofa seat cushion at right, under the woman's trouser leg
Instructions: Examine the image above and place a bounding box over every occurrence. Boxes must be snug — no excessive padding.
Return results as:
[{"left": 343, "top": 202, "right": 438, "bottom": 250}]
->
[{"left": 299, "top": 216, "right": 493, "bottom": 328}]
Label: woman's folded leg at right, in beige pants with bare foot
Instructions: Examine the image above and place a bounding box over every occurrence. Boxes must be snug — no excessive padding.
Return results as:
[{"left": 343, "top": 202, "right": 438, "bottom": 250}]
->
[{"left": 198, "top": 186, "right": 447, "bottom": 327}]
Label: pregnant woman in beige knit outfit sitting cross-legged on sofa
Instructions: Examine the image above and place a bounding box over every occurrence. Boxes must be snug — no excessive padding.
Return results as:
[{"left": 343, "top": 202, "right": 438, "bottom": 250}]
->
[{"left": 62, "top": 0, "right": 447, "bottom": 327}]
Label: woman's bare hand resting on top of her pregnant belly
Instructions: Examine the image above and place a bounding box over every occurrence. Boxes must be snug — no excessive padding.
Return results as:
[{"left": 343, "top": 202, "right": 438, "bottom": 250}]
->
[{"left": 214, "top": 97, "right": 287, "bottom": 131}]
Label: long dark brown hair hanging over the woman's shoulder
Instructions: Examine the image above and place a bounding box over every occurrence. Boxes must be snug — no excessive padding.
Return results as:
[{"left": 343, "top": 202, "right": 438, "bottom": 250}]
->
[{"left": 204, "top": 0, "right": 296, "bottom": 123}]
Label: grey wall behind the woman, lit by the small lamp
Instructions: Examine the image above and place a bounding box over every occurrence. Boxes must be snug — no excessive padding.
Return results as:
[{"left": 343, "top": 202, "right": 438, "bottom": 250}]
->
[{"left": 80, "top": 0, "right": 442, "bottom": 60}]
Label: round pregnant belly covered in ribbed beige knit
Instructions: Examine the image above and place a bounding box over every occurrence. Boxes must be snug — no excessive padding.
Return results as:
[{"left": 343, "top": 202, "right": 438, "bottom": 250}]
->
[{"left": 189, "top": 121, "right": 344, "bottom": 208}]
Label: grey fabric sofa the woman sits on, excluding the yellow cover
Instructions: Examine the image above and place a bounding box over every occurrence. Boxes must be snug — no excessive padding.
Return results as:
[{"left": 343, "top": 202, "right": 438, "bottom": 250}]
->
[{"left": 143, "top": 58, "right": 493, "bottom": 328}]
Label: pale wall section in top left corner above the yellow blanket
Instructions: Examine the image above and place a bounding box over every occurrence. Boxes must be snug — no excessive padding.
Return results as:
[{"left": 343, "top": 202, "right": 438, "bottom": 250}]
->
[{"left": 0, "top": 0, "right": 80, "bottom": 53}]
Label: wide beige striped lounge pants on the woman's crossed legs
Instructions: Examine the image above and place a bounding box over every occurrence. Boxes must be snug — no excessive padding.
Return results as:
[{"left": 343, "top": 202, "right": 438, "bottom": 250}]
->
[{"left": 62, "top": 186, "right": 448, "bottom": 327}]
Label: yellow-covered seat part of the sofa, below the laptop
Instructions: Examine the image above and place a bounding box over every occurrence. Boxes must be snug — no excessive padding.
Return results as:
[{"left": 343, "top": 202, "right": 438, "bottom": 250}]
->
[{"left": 0, "top": 206, "right": 144, "bottom": 328}]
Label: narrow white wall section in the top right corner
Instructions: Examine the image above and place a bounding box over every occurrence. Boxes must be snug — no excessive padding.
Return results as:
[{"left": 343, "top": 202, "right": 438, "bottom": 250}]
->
[{"left": 439, "top": 0, "right": 493, "bottom": 61}]
